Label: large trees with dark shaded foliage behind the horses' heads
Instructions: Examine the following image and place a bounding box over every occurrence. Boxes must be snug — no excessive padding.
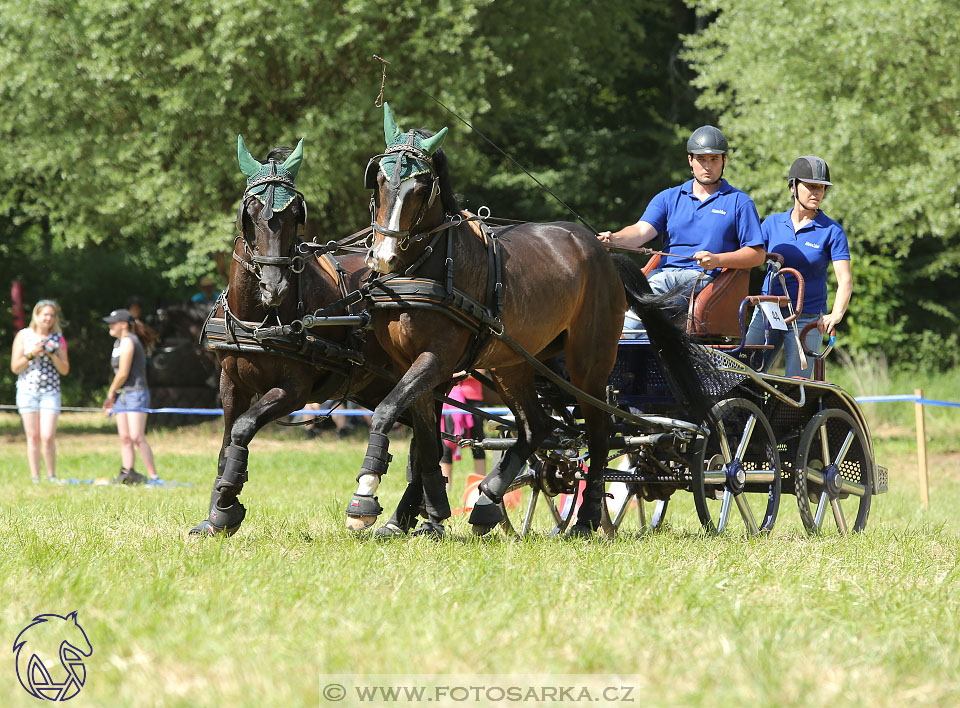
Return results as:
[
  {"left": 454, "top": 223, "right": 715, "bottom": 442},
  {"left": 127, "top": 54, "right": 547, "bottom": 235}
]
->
[{"left": 0, "top": 0, "right": 695, "bottom": 402}]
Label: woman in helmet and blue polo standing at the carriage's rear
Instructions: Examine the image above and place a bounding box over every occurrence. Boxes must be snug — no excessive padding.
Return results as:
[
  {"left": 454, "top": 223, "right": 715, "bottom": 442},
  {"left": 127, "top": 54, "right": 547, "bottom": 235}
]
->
[{"left": 746, "top": 155, "right": 853, "bottom": 377}]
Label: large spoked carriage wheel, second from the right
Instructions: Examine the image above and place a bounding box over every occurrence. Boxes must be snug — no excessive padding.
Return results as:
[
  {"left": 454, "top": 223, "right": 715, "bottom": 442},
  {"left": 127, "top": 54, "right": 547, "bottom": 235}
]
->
[{"left": 691, "top": 398, "right": 780, "bottom": 536}]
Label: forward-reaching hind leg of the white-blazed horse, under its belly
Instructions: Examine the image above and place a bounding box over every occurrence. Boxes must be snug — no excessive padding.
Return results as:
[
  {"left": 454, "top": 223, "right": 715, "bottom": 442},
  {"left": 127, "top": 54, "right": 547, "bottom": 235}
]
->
[{"left": 470, "top": 364, "right": 549, "bottom": 535}]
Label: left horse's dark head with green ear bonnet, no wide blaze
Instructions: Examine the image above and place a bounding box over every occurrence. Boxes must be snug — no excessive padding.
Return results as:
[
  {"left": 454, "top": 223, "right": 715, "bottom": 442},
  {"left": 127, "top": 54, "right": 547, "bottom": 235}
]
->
[{"left": 234, "top": 135, "right": 307, "bottom": 307}]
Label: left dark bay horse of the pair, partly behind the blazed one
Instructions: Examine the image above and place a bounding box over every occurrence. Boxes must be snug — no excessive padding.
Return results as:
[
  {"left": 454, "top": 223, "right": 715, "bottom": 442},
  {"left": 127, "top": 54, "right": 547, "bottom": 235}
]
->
[{"left": 190, "top": 137, "right": 443, "bottom": 535}]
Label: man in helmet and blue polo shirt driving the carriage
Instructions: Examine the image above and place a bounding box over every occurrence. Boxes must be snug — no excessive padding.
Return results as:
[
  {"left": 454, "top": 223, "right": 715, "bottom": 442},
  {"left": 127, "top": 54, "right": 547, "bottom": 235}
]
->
[{"left": 597, "top": 125, "right": 766, "bottom": 328}]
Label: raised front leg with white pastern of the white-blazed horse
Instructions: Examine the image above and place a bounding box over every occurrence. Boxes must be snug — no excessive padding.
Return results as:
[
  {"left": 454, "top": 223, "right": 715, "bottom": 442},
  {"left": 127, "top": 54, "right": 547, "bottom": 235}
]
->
[{"left": 346, "top": 352, "right": 450, "bottom": 531}]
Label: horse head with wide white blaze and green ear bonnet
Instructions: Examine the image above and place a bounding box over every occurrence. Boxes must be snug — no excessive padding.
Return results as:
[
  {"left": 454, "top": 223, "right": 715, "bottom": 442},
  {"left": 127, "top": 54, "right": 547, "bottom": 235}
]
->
[{"left": 364, "top": 103, "right": 456, "bottom": 273}]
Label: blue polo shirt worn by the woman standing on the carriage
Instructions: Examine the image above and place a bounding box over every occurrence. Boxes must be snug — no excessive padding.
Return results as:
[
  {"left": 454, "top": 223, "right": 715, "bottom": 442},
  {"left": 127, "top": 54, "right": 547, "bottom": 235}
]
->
[{"left": 761, "top": 209, "right": 850, "bottom": 315}]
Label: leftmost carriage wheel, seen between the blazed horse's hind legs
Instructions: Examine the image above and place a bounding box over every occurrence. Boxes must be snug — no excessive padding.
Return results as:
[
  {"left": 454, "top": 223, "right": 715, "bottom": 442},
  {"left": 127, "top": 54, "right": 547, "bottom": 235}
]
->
[{"left": 500, "top": 459, "right": 581, "bottom": 538}]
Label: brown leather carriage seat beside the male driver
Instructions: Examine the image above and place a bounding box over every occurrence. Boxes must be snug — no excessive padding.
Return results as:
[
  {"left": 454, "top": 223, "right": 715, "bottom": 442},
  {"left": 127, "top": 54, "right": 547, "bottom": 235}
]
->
[{"left": 643, "top": 255, "right": 750, "bottom": 339}]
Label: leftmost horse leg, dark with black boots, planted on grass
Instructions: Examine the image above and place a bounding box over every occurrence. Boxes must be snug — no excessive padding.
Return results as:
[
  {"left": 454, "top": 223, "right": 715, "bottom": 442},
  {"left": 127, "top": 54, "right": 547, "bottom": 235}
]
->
[{"left": 191, "top": 380, "right": 309, "bottom": 536}]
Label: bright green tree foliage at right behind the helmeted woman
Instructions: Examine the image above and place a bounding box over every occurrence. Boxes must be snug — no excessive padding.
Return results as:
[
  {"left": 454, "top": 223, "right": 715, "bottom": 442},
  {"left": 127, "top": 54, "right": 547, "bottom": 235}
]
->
[{"left": 685, "top": 0, "right": 960, "bottom": 365}]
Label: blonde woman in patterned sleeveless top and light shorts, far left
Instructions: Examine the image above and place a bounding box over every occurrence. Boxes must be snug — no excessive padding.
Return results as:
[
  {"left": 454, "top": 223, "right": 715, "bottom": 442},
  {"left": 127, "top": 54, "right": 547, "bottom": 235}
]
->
[{"left": 10, "top": 300, "right": 70, "bottom": 483}]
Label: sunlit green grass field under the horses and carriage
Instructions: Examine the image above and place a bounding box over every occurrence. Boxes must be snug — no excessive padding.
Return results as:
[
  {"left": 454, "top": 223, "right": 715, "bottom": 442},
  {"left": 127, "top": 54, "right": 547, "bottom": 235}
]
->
[{"left": 0, "top": 415, "right": 960, "bottom": 708}]
